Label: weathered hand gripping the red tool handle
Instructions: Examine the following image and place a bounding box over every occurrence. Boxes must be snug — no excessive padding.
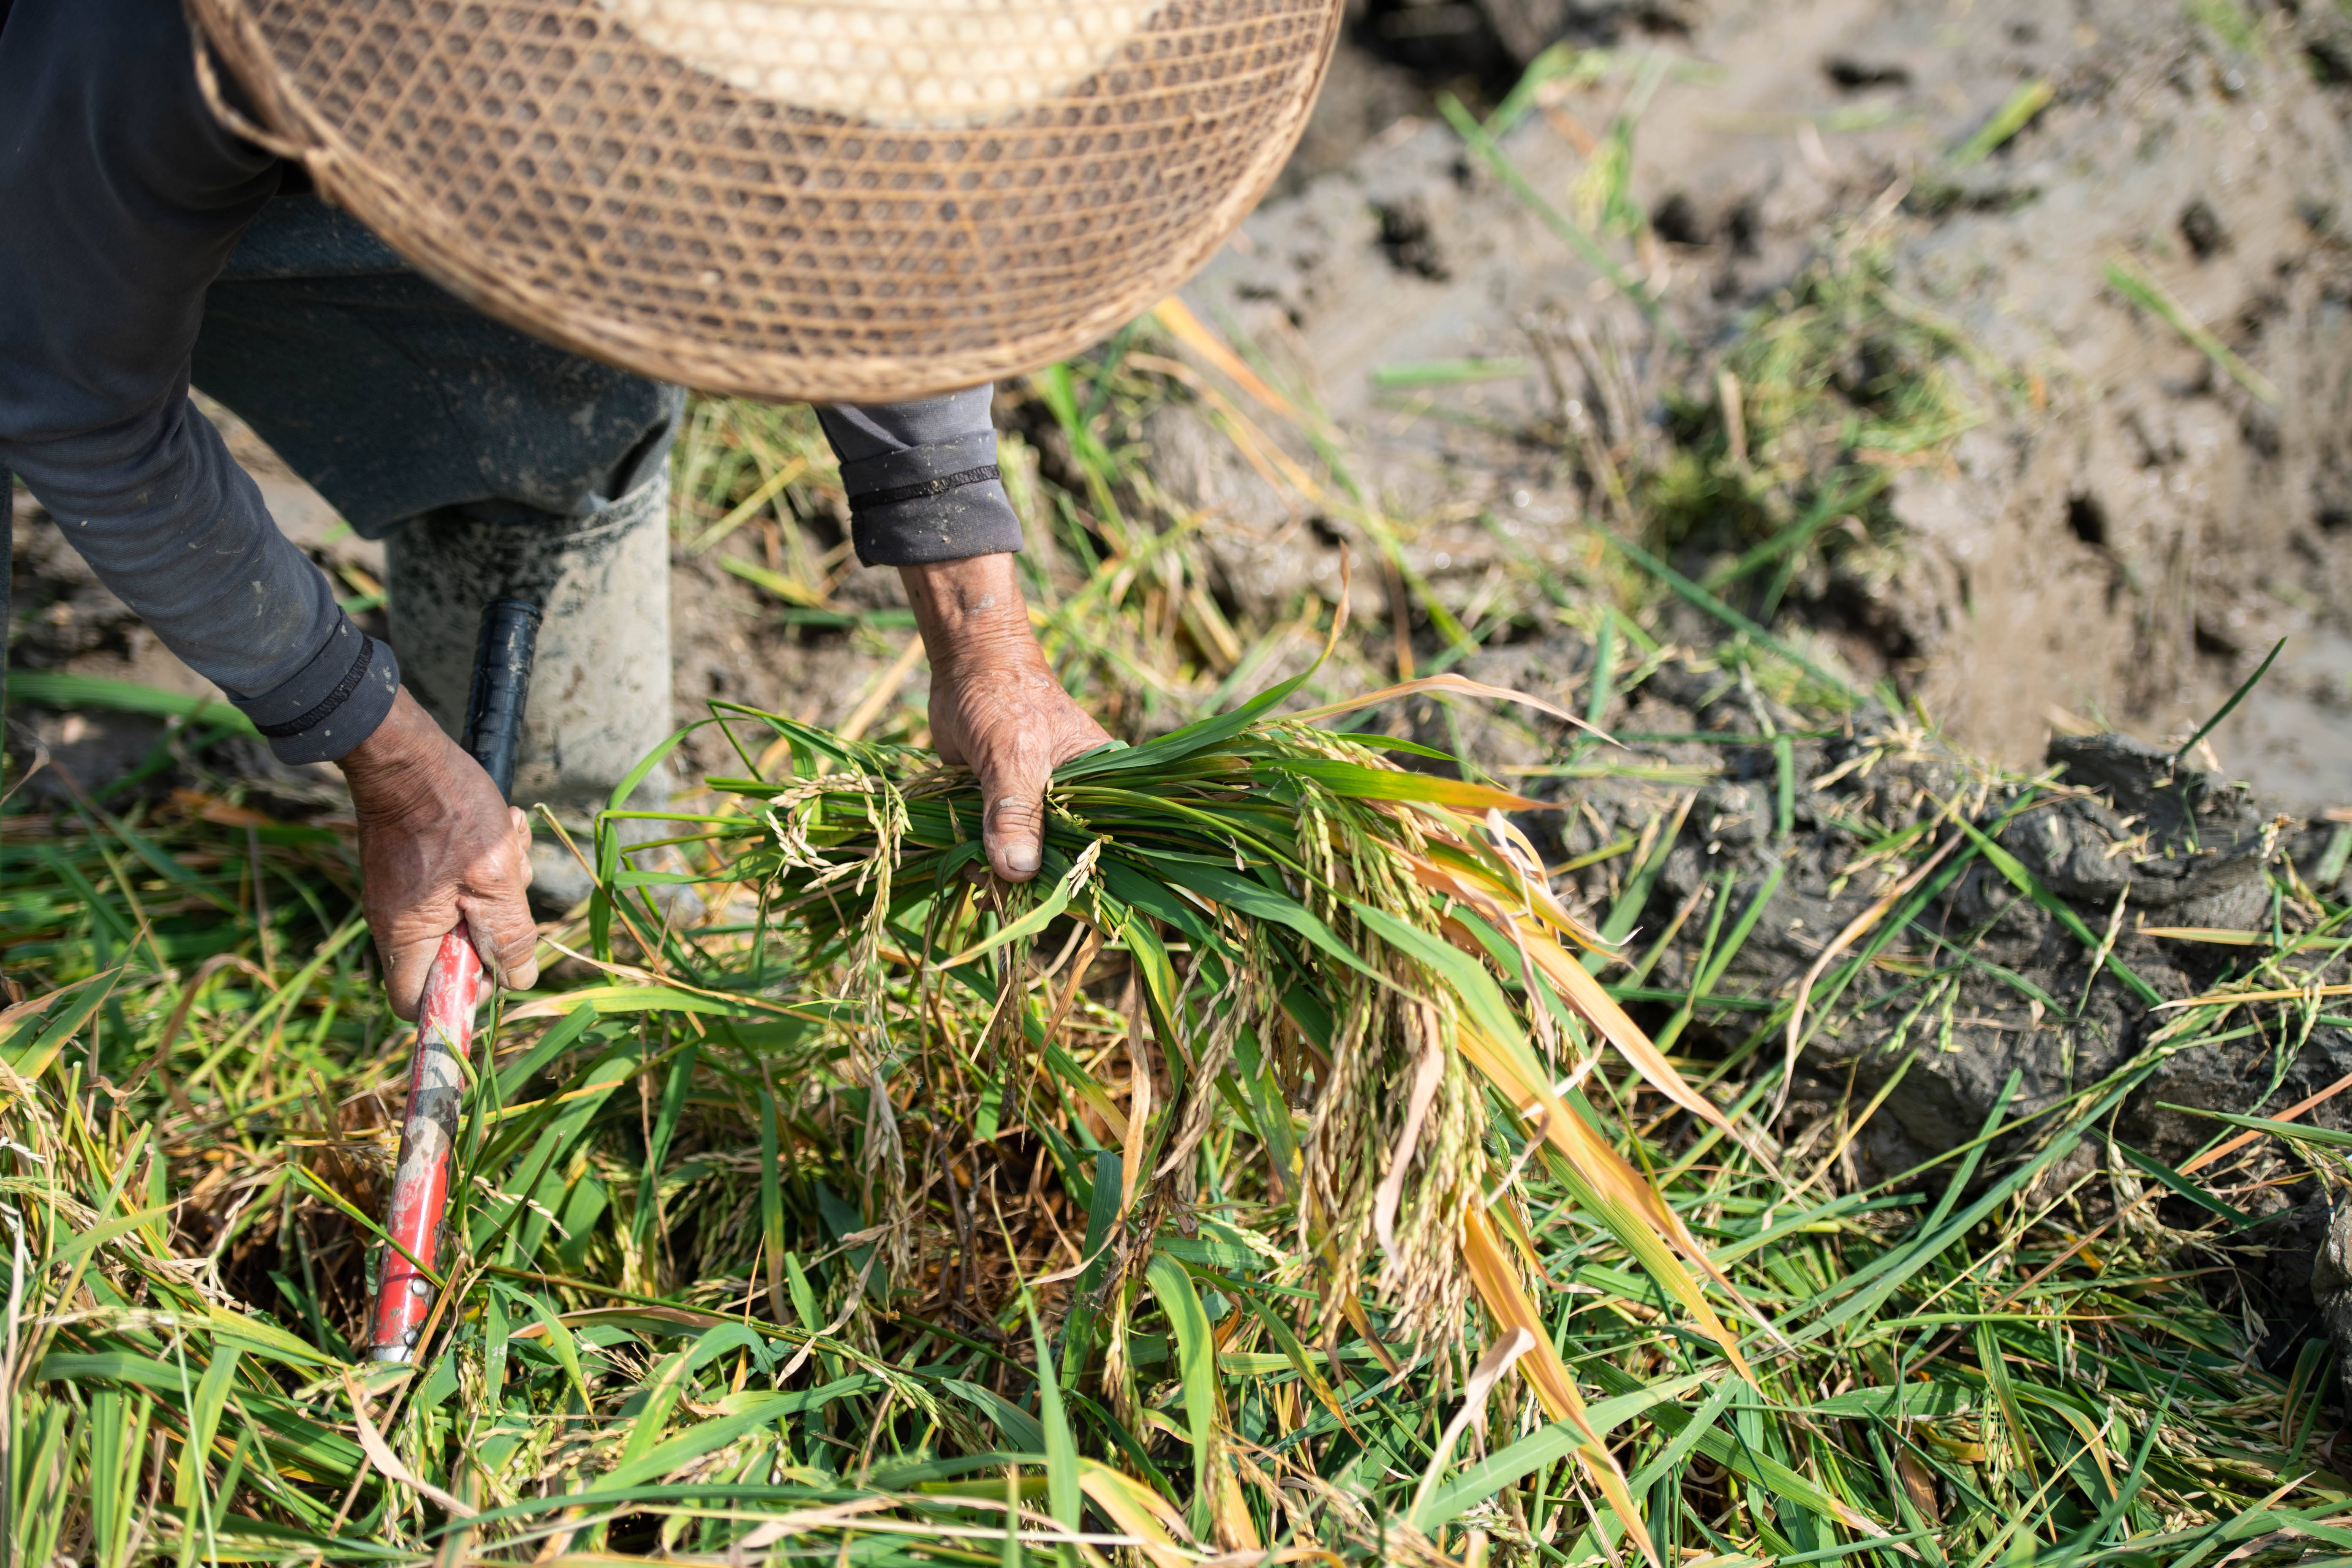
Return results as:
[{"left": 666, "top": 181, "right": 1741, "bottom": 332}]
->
[{"left": 343, "top": 686, "right": 539, "bottom": 1020}]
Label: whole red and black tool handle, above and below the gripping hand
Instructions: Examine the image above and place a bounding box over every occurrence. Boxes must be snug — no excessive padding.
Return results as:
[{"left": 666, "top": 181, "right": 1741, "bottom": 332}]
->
[{"left": 367, "top": 599, "right": 539, "bottom": 1361}]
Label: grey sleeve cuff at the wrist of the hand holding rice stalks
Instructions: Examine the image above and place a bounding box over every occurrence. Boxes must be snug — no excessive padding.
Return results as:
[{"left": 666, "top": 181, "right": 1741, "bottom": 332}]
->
[{"left": 842, "top": 430, "right": 1021, "bottom": 566}]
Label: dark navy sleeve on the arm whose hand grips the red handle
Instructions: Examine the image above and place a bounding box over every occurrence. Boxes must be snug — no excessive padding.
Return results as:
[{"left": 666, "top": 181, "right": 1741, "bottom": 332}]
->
[{"left": 0, "top": 0, "right": 400, "bottom": 762}]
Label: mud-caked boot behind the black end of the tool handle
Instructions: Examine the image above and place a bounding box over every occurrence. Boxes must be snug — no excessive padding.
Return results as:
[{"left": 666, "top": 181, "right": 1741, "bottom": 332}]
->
[{"left": 386, "top": 468, "right": 684, "bottom": 917}]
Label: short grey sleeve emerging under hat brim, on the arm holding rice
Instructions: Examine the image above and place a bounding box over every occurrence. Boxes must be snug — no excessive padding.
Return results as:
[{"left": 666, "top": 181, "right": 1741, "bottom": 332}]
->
[{"left": 816, "top": 386, "right": 1021, "bottom": 566}]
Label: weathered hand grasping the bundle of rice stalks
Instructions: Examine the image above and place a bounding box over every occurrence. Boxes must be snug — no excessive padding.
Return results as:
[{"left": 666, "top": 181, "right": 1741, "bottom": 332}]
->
[{"left": 898, "top": 555, "right": 1110, "bottom": 882}]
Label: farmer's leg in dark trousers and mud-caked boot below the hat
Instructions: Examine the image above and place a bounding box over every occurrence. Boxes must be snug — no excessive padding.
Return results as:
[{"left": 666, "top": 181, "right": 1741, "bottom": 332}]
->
[{"left": 193, "top": 195, "right": 684, "bottom": 822}]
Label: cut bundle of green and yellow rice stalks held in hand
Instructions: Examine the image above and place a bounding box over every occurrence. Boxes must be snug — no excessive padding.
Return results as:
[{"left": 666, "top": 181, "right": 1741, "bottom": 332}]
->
[{"left": 672, "top": 632, "right": 1752, "bottom": 1559}]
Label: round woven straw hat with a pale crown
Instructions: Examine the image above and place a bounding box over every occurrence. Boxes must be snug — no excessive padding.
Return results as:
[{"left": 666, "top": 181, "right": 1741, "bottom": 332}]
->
[{"left": 188, "top": 0, "right": 1341, "bottom": 402}]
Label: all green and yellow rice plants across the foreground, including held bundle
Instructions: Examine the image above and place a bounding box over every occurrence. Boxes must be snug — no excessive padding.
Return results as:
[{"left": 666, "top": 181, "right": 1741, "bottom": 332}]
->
[{"left": 0, "top": 639, "right": 2352, "bottom": 1568}]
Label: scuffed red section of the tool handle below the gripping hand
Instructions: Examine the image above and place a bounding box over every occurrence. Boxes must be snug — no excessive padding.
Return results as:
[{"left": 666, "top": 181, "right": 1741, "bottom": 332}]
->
[{"left": 367, "top": 919, "right": 482, "bottom": 1361}]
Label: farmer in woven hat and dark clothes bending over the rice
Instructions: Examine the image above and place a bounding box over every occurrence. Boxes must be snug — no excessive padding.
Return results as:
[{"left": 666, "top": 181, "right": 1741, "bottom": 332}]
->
[{"left": 0, "top": 0, "right": 1331, "bottom": 1018}]
